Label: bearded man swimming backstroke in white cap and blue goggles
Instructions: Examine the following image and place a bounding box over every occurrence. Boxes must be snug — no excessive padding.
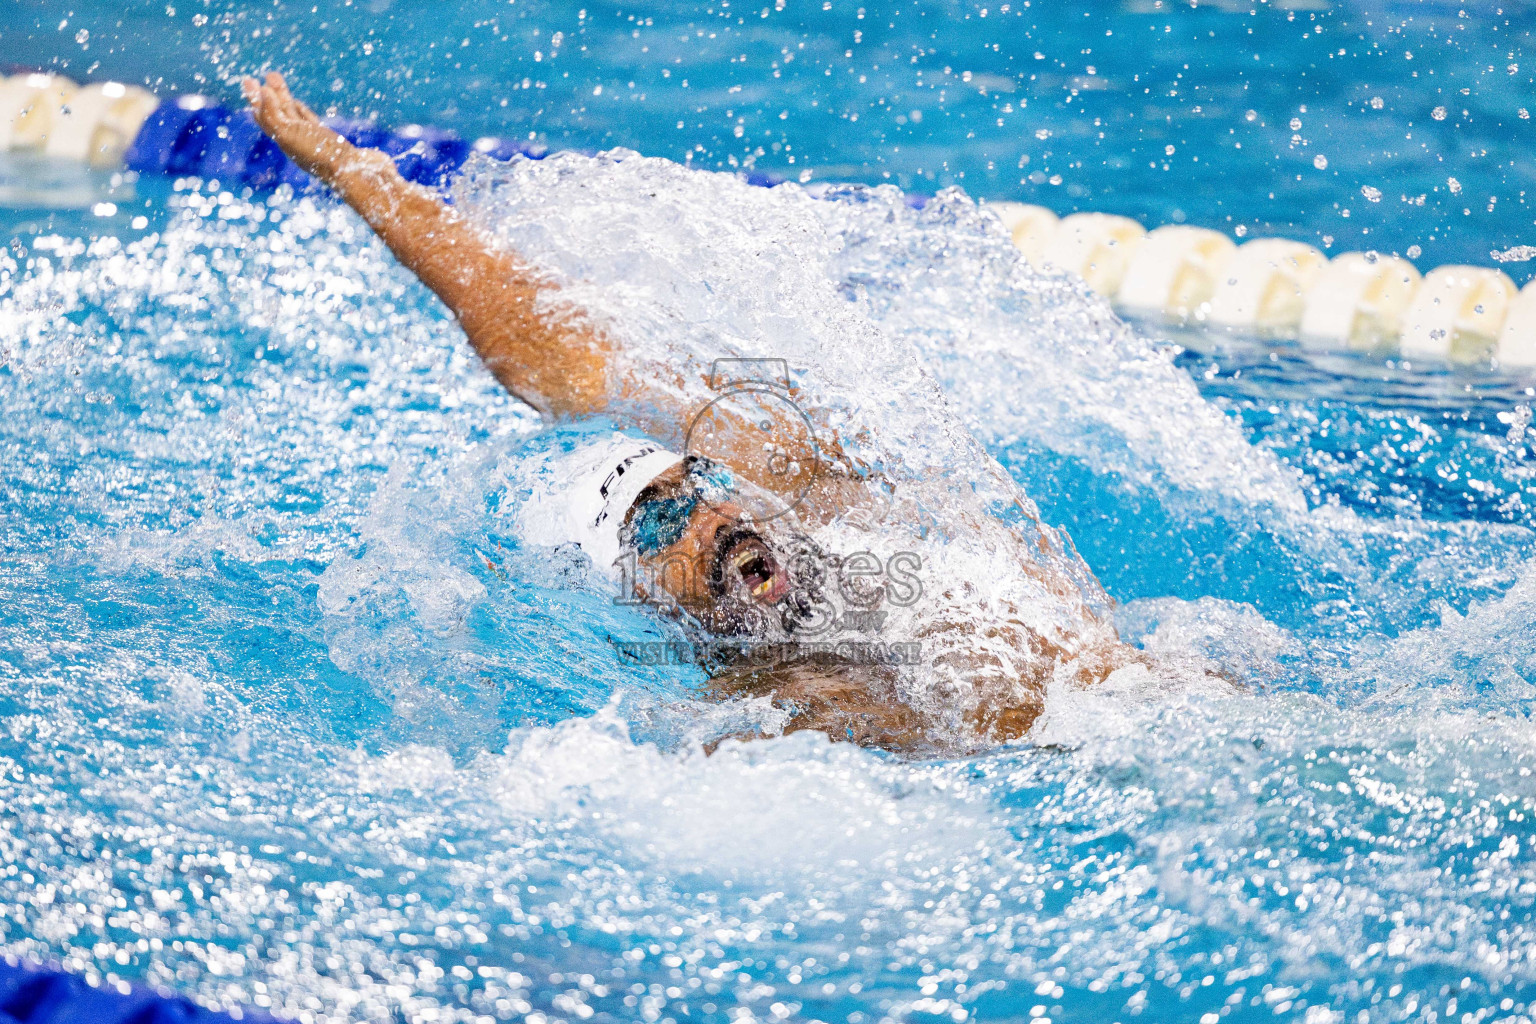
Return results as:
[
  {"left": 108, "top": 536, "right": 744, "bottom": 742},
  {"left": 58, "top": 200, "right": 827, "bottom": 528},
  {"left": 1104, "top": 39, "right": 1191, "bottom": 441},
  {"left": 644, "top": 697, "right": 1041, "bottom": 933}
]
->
[{"left": 243, "top": 72, "right": 1143, "bottom": 752}]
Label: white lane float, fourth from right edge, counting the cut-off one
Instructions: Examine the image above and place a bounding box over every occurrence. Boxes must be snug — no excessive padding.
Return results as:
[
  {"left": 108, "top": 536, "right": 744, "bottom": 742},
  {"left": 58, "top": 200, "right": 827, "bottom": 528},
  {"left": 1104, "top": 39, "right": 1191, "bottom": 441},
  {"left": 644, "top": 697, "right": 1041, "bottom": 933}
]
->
[{"left": 1209, "top": 238, "right": 1329, "bottom": 338}]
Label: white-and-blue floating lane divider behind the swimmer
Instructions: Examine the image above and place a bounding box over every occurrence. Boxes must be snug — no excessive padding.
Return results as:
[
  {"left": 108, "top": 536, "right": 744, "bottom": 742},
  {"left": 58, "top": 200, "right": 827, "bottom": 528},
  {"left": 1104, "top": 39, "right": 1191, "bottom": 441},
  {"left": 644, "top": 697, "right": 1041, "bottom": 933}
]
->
[{"left": 0, "top": 72, "right": 1536, "bottom": 367}]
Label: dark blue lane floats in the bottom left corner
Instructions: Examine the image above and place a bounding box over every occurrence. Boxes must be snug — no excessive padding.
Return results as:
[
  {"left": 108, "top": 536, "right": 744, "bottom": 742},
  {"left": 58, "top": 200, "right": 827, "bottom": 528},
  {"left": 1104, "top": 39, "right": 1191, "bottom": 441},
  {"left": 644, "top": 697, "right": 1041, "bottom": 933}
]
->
[{"left": 0, "top": 958, "right": 278, "bottom": 1024}]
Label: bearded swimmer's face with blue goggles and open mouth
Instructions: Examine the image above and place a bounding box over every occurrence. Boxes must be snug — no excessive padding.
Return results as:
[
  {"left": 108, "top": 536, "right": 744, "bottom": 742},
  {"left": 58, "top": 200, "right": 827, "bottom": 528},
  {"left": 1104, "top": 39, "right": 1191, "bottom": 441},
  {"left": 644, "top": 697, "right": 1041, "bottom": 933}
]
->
[{"left": 622, "top": 457, "right": 808, "bottom": 634}]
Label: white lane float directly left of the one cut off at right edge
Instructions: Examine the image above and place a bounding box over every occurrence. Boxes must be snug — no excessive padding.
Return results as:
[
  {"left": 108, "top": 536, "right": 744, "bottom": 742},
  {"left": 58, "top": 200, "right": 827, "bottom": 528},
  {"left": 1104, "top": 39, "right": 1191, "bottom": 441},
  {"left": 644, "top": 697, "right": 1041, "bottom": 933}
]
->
[{"left": 1398, "top": 266, "right": 1516, "bottom": 362}]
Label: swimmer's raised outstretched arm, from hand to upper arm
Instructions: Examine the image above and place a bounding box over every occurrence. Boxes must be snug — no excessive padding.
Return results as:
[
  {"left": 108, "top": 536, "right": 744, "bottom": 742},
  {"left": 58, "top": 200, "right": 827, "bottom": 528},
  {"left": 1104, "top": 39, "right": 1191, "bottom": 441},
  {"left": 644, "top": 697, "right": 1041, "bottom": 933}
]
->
[{"left": 243, "top": 72, "right": 610, "bottom": 416}]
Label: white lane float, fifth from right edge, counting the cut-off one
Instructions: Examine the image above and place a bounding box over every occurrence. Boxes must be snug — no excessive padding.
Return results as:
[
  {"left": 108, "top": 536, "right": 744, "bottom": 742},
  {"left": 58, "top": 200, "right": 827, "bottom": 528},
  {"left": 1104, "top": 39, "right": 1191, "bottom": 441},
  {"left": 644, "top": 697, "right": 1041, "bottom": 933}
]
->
[{"left": 1112, "top": 224, "right": 1238, "bottom": 322}]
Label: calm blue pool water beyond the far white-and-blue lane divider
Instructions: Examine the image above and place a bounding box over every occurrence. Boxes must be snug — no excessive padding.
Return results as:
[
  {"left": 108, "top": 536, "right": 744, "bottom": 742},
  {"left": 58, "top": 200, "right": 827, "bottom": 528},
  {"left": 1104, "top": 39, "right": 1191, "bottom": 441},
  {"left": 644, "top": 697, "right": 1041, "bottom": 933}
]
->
[{"left": 9, "top": 0, "right": 1536, "bottom": 271}]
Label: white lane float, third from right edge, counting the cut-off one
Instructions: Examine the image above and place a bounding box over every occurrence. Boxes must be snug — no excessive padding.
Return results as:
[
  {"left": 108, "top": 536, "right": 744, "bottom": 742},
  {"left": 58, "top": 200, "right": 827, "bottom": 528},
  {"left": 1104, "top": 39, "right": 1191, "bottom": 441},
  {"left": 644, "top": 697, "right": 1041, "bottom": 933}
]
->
[{"left": 1301, "top": 252, "right": 1422, "bottom": 352}]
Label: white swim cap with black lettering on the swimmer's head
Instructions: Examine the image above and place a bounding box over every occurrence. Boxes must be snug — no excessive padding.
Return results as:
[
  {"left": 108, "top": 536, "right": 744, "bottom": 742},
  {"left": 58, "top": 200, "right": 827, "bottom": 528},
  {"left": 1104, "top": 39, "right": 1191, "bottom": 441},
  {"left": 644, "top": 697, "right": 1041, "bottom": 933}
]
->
[{"left": 519, "top": 434, "right": 682, "bottom": 574}]
